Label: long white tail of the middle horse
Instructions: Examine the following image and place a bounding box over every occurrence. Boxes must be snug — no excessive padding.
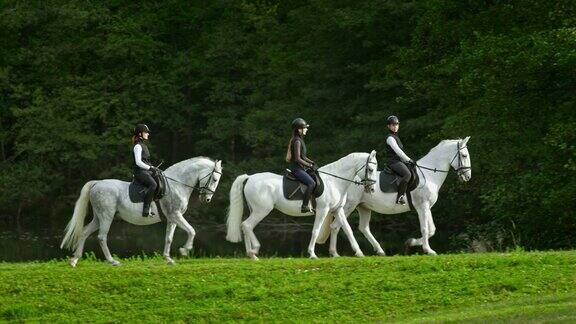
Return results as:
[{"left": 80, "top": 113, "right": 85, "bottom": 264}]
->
[{"left": 226, "top": 174, "right": 250, "bottom": 243}]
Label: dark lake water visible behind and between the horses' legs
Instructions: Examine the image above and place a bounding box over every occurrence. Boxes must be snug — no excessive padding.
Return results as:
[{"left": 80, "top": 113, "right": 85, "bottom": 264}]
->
[{"left": 0, "top": 217, "right": 447, "bottom": 262}]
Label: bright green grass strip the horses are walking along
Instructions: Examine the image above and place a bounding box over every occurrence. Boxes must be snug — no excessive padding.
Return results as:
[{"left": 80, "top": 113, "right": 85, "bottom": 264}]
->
[{"left": 0, "top": 251, "right": 576, "bottom": 323}]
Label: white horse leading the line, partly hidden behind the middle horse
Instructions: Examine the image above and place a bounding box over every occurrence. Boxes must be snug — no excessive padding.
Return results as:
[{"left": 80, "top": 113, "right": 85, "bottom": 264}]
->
[{"left": 326, "top": 136, "right": 472, "bottom": 257}]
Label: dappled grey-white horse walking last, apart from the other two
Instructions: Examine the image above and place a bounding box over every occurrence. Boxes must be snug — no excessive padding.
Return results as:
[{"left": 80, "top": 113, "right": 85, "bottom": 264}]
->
[{"left": 60, "top": 157, "right": 222, "bottom": 267}]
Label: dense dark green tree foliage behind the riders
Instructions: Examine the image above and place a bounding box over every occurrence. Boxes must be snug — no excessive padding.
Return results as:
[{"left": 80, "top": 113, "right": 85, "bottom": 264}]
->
[{"left": 0, "top": 0, "right": 576, "bottom": 249}]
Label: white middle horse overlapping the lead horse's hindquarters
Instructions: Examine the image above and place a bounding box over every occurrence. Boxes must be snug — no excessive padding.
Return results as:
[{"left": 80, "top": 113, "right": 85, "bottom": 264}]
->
[{"left": 226, "top": 151, "right": 378, "bottom": 260}]
